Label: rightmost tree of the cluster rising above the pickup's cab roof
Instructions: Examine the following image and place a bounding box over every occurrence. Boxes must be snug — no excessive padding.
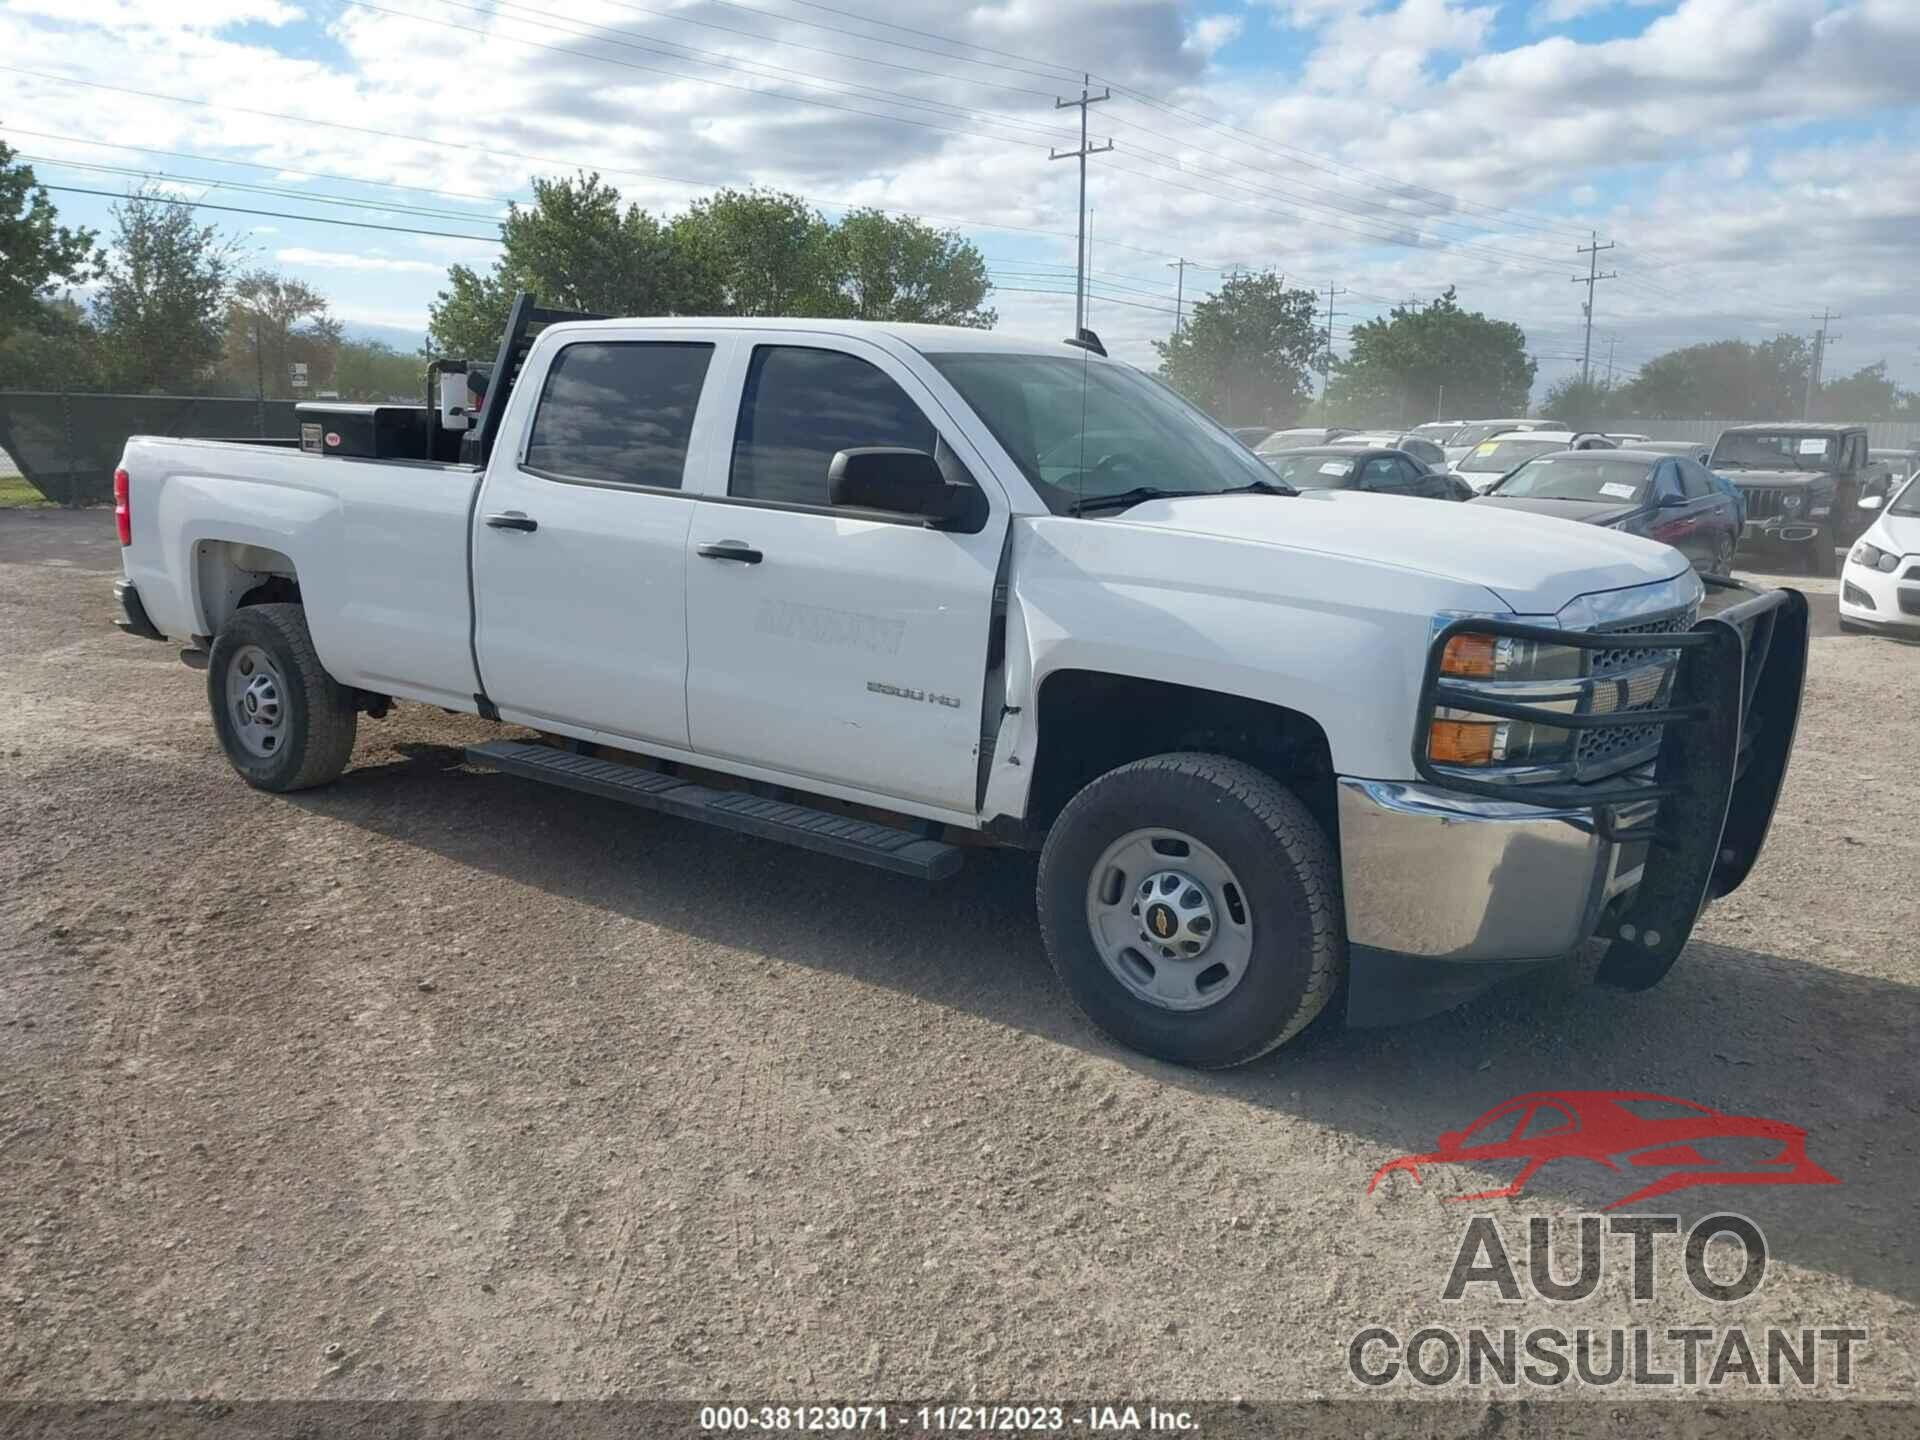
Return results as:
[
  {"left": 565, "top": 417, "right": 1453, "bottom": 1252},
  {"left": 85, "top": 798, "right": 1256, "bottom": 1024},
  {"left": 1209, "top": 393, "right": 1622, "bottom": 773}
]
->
[{"left": 833, "top": 209, "right": 998, "bottom": 330}]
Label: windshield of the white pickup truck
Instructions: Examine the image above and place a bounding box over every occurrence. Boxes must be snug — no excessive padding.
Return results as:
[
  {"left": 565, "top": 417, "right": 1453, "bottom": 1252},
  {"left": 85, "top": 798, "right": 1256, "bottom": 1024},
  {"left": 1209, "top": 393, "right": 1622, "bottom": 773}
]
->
[{"left": 927, "top": 351, "right": 1273, "bottom": 515}]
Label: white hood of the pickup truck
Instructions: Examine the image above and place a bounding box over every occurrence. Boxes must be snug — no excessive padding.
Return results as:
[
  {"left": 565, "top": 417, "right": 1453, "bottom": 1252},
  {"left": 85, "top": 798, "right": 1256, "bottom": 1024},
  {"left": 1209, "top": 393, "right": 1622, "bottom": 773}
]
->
[{"left": 1114, "top": 490, "right": 1688, "bottom": 614}]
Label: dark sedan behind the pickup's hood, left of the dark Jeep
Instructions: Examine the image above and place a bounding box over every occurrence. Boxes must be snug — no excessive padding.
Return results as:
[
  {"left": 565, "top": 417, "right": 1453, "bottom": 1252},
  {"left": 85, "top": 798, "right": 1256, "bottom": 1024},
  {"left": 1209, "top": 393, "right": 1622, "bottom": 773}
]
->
[{"left": 1473, "top": 449, "right": 1740, "bottom": 574}]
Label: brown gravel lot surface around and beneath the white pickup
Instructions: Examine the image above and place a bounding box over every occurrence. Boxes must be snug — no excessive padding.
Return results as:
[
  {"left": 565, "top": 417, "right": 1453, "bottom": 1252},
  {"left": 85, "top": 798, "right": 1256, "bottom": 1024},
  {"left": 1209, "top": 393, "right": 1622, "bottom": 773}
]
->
[{"left": 0, "top": 513, "right": 1920, "bottom": 1400}]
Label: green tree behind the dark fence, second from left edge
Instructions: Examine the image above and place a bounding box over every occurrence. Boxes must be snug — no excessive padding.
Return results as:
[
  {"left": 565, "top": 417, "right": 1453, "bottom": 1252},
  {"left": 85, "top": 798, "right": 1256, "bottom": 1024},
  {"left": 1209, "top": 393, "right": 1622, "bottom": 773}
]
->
[{"left": 94, "top": 190, "right": 236, "bottom": 390}]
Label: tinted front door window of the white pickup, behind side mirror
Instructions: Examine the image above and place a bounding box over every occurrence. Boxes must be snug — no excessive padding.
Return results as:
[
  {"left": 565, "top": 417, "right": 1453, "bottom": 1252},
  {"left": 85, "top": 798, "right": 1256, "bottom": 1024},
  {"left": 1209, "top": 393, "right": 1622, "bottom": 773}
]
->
[{"left": 728, "top": 346, "right": 939, "bottom": 505}]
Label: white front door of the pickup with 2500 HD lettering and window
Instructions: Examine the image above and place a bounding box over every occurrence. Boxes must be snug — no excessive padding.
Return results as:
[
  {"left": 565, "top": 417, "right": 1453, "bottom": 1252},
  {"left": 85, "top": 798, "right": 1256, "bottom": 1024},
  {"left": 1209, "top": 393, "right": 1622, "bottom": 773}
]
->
[{"left": 687, "top": 334, "right": 1006, "bottom": 812}]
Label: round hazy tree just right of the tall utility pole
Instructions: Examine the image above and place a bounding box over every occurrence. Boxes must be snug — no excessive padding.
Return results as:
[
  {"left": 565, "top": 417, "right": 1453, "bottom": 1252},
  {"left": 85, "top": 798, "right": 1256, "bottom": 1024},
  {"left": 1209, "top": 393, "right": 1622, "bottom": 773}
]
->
[{"left": 1154, "top": 271, "right": 1321, "bottom": 424}]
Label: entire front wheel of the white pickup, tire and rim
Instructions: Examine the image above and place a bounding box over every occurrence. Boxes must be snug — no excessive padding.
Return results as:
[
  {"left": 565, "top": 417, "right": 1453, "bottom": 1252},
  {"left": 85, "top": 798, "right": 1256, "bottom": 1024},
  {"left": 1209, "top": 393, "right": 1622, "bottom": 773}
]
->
[{"left": 1039, "top": 753, "right": 1346, "bottom": 1069}]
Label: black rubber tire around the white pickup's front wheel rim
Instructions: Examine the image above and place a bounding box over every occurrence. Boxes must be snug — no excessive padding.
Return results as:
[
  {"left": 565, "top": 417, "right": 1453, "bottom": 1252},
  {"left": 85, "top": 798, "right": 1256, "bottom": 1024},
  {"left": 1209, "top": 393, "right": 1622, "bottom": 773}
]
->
[{"left": 1039, "top": 753, "right": 1346, "bottom": 1069}]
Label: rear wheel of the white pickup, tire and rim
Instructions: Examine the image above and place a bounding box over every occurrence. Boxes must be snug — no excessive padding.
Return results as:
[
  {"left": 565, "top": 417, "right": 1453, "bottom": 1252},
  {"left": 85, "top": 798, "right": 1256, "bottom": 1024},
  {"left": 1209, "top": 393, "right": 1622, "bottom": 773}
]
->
[{"left": 207, "top": 605, "right": 357, "bottom": 791}]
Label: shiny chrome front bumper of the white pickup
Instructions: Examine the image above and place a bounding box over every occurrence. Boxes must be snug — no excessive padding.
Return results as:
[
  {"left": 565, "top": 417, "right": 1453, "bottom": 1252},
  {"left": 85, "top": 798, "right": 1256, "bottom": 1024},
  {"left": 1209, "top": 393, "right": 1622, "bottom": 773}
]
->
[{"left": 1338, "top": 778, "right": 1659, "bottom": 962}]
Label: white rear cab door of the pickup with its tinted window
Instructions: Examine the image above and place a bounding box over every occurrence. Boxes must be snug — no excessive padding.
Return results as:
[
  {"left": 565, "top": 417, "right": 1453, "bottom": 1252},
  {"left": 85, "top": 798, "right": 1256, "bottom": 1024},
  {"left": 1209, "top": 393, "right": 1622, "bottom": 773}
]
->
[{"left": 472, "top": 330, "right": 728, "bottom": 749}]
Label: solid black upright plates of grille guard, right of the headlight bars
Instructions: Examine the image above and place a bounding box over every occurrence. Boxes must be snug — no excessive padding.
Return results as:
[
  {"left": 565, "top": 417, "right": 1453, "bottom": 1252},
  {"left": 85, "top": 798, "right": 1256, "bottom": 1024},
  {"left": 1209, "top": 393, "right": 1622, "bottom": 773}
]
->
[{"left": 1597, "top": 589, "right": 1807, "bottom": 991}]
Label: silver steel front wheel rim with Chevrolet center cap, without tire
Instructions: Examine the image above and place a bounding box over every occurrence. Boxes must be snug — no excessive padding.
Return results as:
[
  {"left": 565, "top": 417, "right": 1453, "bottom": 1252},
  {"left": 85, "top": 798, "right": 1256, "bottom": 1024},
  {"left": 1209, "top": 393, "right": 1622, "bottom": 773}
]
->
[{"left": 1087, "top": 829, "right": 1254, "bottom": 1010}]
